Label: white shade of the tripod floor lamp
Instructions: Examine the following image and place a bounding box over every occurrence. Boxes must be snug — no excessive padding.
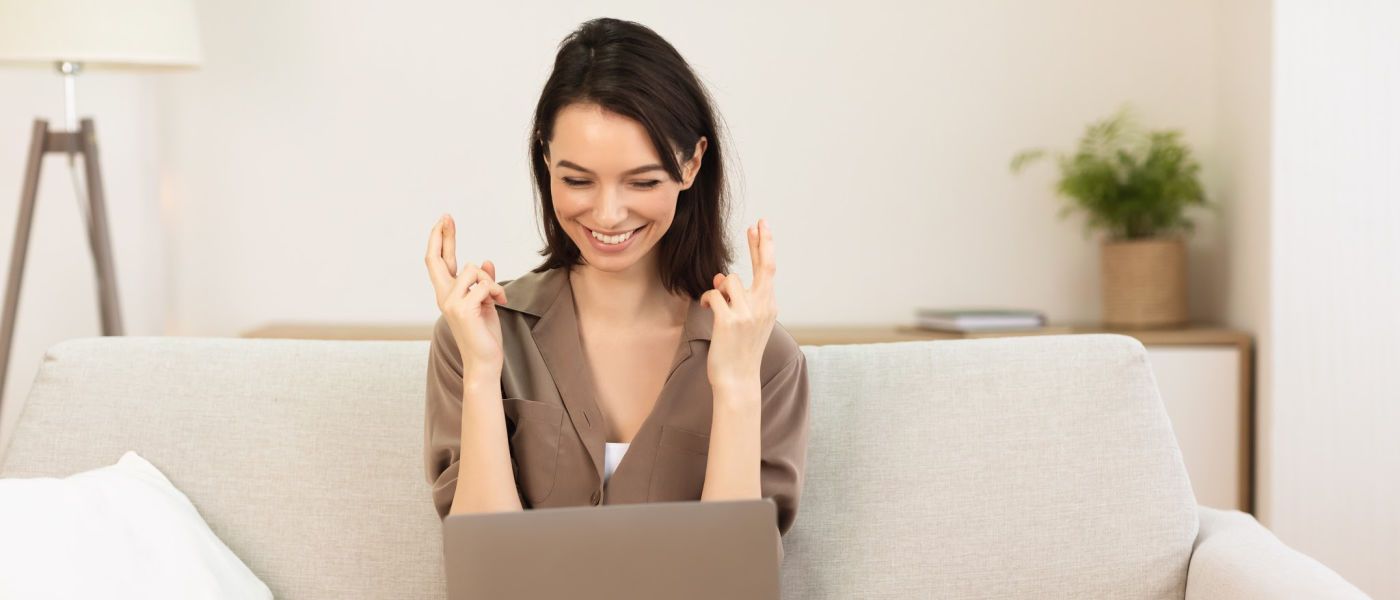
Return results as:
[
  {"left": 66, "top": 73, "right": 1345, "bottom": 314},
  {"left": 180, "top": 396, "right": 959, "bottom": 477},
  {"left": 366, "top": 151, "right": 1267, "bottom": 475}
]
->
[{"left": 0, "top": 0, "right": 202, "bottom": 69}]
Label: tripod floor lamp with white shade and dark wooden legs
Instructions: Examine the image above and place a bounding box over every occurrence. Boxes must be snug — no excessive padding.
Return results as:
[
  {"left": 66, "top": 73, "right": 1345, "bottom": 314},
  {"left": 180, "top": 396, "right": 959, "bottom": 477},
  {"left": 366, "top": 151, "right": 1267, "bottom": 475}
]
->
[{"left": 0, "top": 0, "right": 200, "bottom": 419}]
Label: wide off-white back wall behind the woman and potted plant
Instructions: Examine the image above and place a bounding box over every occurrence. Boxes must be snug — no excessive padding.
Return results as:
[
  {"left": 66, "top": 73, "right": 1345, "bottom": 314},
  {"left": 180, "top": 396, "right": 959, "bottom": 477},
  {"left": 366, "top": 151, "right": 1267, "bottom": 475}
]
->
[{"left": 161, "top": 0, "right": 1225, "bottom": 334}]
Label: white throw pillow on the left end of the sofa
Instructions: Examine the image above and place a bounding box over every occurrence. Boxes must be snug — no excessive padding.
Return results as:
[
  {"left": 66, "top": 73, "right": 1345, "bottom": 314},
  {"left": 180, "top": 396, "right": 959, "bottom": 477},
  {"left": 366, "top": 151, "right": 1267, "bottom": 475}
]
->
[{"left": 0, "top": 452, "right": 272, "bottom": 599}]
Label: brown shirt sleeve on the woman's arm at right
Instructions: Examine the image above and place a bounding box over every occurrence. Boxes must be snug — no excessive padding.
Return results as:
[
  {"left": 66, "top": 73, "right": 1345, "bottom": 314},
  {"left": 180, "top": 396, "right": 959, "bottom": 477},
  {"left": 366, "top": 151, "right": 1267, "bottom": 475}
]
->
[{"left": 759, "top": 345, "right": 808, "bottom": 536}]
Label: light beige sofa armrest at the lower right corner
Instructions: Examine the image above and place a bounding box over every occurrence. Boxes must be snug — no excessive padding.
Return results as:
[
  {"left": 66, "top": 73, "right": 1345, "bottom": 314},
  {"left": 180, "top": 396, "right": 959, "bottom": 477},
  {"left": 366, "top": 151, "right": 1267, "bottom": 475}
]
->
[{"left": 1186, "top": 506, "right": 1369, "bottom": 600}]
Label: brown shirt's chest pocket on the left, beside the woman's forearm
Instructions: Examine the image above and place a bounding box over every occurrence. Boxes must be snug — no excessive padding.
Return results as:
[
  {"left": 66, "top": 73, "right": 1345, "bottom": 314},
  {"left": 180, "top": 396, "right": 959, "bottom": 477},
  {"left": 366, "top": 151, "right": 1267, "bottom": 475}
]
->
[{"left": 501, "top": 397, "right": 564, "bottom": 508}]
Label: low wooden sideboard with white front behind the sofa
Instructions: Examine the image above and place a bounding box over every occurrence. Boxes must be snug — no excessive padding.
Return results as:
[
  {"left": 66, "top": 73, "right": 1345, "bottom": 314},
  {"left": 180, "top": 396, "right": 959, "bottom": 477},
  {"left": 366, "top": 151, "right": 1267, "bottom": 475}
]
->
[{"left": 244, "top": 323, "right": 1254, "bottom": 512}]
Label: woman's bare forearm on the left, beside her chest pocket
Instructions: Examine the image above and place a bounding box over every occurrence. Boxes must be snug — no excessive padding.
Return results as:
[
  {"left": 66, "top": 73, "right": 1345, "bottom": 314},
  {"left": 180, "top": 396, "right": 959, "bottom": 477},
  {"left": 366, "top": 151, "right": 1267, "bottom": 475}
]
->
[{"left": 449, "top": 376, "right": 522, "bottom": 515}]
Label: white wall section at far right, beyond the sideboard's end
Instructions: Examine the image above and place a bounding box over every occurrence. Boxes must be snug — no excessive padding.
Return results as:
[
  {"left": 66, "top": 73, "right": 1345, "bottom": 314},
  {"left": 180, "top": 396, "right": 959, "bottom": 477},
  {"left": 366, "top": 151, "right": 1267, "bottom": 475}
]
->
[{"left": 1268, "top": 0, "right": 1400, "bottom": 599}]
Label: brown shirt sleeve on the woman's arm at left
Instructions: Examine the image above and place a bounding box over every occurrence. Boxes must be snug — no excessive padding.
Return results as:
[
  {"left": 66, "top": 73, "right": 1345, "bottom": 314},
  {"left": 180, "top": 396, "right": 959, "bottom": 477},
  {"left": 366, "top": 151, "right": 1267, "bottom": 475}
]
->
[{"left": 423, "top": 316, "right": 525, "bottom": 519}]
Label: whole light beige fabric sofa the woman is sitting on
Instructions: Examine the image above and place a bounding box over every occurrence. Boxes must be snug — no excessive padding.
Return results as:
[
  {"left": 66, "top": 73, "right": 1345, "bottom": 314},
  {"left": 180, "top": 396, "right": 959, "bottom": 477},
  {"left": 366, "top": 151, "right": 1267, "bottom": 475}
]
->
[{"left": 0, "top": 334, "right": 1366, "bottom": 600}]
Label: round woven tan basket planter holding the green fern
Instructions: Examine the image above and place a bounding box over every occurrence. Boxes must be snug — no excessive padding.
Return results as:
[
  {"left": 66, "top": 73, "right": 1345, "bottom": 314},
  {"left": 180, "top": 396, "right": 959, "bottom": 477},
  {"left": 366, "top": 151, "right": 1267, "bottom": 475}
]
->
[{"left": 1099, "top": 238, "right": 1187, "bottom": 327}]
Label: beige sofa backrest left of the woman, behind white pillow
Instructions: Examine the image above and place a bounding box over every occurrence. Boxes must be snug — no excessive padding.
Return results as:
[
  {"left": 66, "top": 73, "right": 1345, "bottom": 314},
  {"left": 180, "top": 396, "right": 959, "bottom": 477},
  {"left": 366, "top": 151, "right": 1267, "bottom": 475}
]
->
[{"left": 0, "top": 337, "right": 445, "bottom": 600}]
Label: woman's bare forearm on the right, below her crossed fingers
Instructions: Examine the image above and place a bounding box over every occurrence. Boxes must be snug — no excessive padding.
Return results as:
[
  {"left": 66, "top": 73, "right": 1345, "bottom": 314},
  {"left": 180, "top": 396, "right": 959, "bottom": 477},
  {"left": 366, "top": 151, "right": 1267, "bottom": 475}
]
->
[{"left": 700, "top": 378, "right": 763, "bottom": 501}]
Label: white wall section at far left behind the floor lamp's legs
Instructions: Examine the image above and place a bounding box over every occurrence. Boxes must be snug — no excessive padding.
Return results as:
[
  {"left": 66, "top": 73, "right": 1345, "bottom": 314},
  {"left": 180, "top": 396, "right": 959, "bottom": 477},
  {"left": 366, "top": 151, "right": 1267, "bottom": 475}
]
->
[{"left": 0, "top": 67, "right": 169, "bottom": 453}]
